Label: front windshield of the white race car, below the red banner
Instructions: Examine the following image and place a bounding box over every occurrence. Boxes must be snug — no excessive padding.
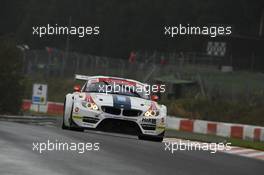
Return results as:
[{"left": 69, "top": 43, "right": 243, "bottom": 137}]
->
[{"left": 84, "top": 81, "right": 150, "bottom": 99}]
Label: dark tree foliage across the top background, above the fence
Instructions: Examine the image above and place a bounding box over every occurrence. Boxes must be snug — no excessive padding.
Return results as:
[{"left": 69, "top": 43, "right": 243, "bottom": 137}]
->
[{"left": 0, "top": 0, "right": 263, "bottom": 58}]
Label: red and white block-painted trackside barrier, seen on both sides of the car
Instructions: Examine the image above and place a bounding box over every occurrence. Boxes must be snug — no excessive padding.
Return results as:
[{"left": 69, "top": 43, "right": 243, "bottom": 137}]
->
[{"left": 22, "top": 100, "right": 264, "bottom": 141}]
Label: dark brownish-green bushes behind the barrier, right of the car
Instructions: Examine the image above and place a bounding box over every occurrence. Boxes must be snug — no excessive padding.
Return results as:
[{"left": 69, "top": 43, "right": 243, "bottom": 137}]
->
[{"left": 165, "top": 95, "right": 264, "bottom": 126}]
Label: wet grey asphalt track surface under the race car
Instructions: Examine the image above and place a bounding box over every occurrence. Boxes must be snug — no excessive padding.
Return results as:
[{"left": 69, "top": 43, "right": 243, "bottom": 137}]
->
[{"left": 0, "top": 116, "right": 264, "bottom": 175}]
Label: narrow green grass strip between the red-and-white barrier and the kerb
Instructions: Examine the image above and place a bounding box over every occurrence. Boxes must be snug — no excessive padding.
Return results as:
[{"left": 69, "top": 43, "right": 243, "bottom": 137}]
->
[{"left": 165, "top": 129, "right": 264, "bottom": 151}]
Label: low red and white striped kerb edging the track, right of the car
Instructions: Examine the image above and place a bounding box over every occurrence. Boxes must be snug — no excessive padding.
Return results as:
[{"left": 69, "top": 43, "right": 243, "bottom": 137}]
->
[{"left": 163, "top": 138, "right": 264, "bottom": 161}]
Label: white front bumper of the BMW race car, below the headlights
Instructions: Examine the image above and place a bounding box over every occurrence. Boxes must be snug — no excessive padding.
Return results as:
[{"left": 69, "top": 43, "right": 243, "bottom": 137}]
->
[{"left": 72, "top": 103, "right": 166, "bottom": 136}]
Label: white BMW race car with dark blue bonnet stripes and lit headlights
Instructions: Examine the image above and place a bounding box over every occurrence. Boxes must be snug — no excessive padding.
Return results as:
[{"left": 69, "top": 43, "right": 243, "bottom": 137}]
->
[{"left": 62, "top": 75, "right": 167, "bottom": 142}]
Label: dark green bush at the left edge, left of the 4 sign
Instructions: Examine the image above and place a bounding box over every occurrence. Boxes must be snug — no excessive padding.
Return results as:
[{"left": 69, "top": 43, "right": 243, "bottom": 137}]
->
[{"left": 0, "top": 40, "right": 24, "bottom": 114}]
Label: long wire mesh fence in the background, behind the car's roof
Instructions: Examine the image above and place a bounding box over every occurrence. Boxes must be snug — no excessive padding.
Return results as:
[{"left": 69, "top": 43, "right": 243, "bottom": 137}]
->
[{"left": 24, "top": 49, "right": 227, "bottom": 81}]
